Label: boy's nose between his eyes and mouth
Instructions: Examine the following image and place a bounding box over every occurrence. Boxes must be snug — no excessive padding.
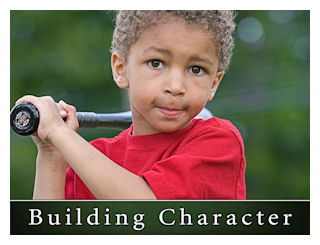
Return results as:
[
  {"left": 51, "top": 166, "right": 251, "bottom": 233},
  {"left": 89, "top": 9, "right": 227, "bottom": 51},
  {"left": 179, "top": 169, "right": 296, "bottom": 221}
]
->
[{"left": 164, "top": 71, "right": 186, "bottom": 96}]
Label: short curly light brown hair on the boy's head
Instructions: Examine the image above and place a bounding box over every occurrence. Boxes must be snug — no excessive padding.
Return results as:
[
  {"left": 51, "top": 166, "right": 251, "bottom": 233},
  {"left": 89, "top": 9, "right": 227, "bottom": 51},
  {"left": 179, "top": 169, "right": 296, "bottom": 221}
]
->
[{"left": 111, "top": 10, "right": 235, "bottom": 71}]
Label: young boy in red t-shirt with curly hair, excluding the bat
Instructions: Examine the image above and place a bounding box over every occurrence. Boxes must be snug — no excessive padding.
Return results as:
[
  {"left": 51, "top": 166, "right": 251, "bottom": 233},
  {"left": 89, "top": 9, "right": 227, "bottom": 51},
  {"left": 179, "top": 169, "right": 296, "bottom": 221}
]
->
[{"left": 17, "top": 11, "right": 245, "bottom": 199}]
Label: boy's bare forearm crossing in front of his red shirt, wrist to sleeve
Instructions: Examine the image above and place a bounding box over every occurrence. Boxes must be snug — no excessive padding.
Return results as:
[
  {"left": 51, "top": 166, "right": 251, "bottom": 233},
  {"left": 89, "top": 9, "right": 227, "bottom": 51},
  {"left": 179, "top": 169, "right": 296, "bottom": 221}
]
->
[{"left": 48, "top": 127, "right": 156, "bottom": 199}]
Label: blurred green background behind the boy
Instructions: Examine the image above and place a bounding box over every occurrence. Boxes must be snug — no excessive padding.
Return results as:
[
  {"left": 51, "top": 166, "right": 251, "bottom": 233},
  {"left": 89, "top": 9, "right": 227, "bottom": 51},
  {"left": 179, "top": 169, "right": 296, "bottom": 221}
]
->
[{"left": 10, "top": 11, "right": 310, "bottom": 199}]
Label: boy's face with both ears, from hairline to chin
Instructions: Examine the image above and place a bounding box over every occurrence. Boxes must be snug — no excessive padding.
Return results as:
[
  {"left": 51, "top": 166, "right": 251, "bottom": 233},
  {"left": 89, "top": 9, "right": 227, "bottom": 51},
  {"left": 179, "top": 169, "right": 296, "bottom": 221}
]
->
[{"left": 112, "top": 19, "right": 224, "bottom": 135}]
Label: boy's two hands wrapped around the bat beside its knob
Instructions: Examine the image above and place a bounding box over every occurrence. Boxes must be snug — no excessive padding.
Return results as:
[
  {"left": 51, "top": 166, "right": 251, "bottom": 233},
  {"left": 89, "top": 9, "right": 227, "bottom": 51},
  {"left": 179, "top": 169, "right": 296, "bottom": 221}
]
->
[{"left": 16, "top": 95, "right": 79, "bottom": 145}]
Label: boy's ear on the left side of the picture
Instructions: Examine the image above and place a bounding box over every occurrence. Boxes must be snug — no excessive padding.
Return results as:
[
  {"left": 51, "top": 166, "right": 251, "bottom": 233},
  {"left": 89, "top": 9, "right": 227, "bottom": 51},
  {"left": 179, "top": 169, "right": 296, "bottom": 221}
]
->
[{"left": 111, "top": 51, "right": 129, "bottom": 88}]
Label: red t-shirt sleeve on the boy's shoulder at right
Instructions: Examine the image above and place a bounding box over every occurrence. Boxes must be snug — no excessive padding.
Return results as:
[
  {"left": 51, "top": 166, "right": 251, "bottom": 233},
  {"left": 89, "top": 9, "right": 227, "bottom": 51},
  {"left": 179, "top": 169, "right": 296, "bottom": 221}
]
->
[{"left": 143, "top": 128, "right": 245, "bottom": 199}]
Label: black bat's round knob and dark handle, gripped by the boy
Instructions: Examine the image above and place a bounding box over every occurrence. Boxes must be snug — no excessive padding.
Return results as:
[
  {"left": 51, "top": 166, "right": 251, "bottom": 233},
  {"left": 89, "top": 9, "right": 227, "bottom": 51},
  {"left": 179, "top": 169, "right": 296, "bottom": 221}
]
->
[{"left": 10, "top": 103, "right": 132, "bottom": 135}]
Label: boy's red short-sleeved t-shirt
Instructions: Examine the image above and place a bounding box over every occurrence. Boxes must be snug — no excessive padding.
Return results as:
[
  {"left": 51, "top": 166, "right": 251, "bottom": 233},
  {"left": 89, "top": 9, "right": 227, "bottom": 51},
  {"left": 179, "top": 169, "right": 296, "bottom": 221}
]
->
[{"left": 65, "top": 117, "right": 246, "bottom": 199}]
